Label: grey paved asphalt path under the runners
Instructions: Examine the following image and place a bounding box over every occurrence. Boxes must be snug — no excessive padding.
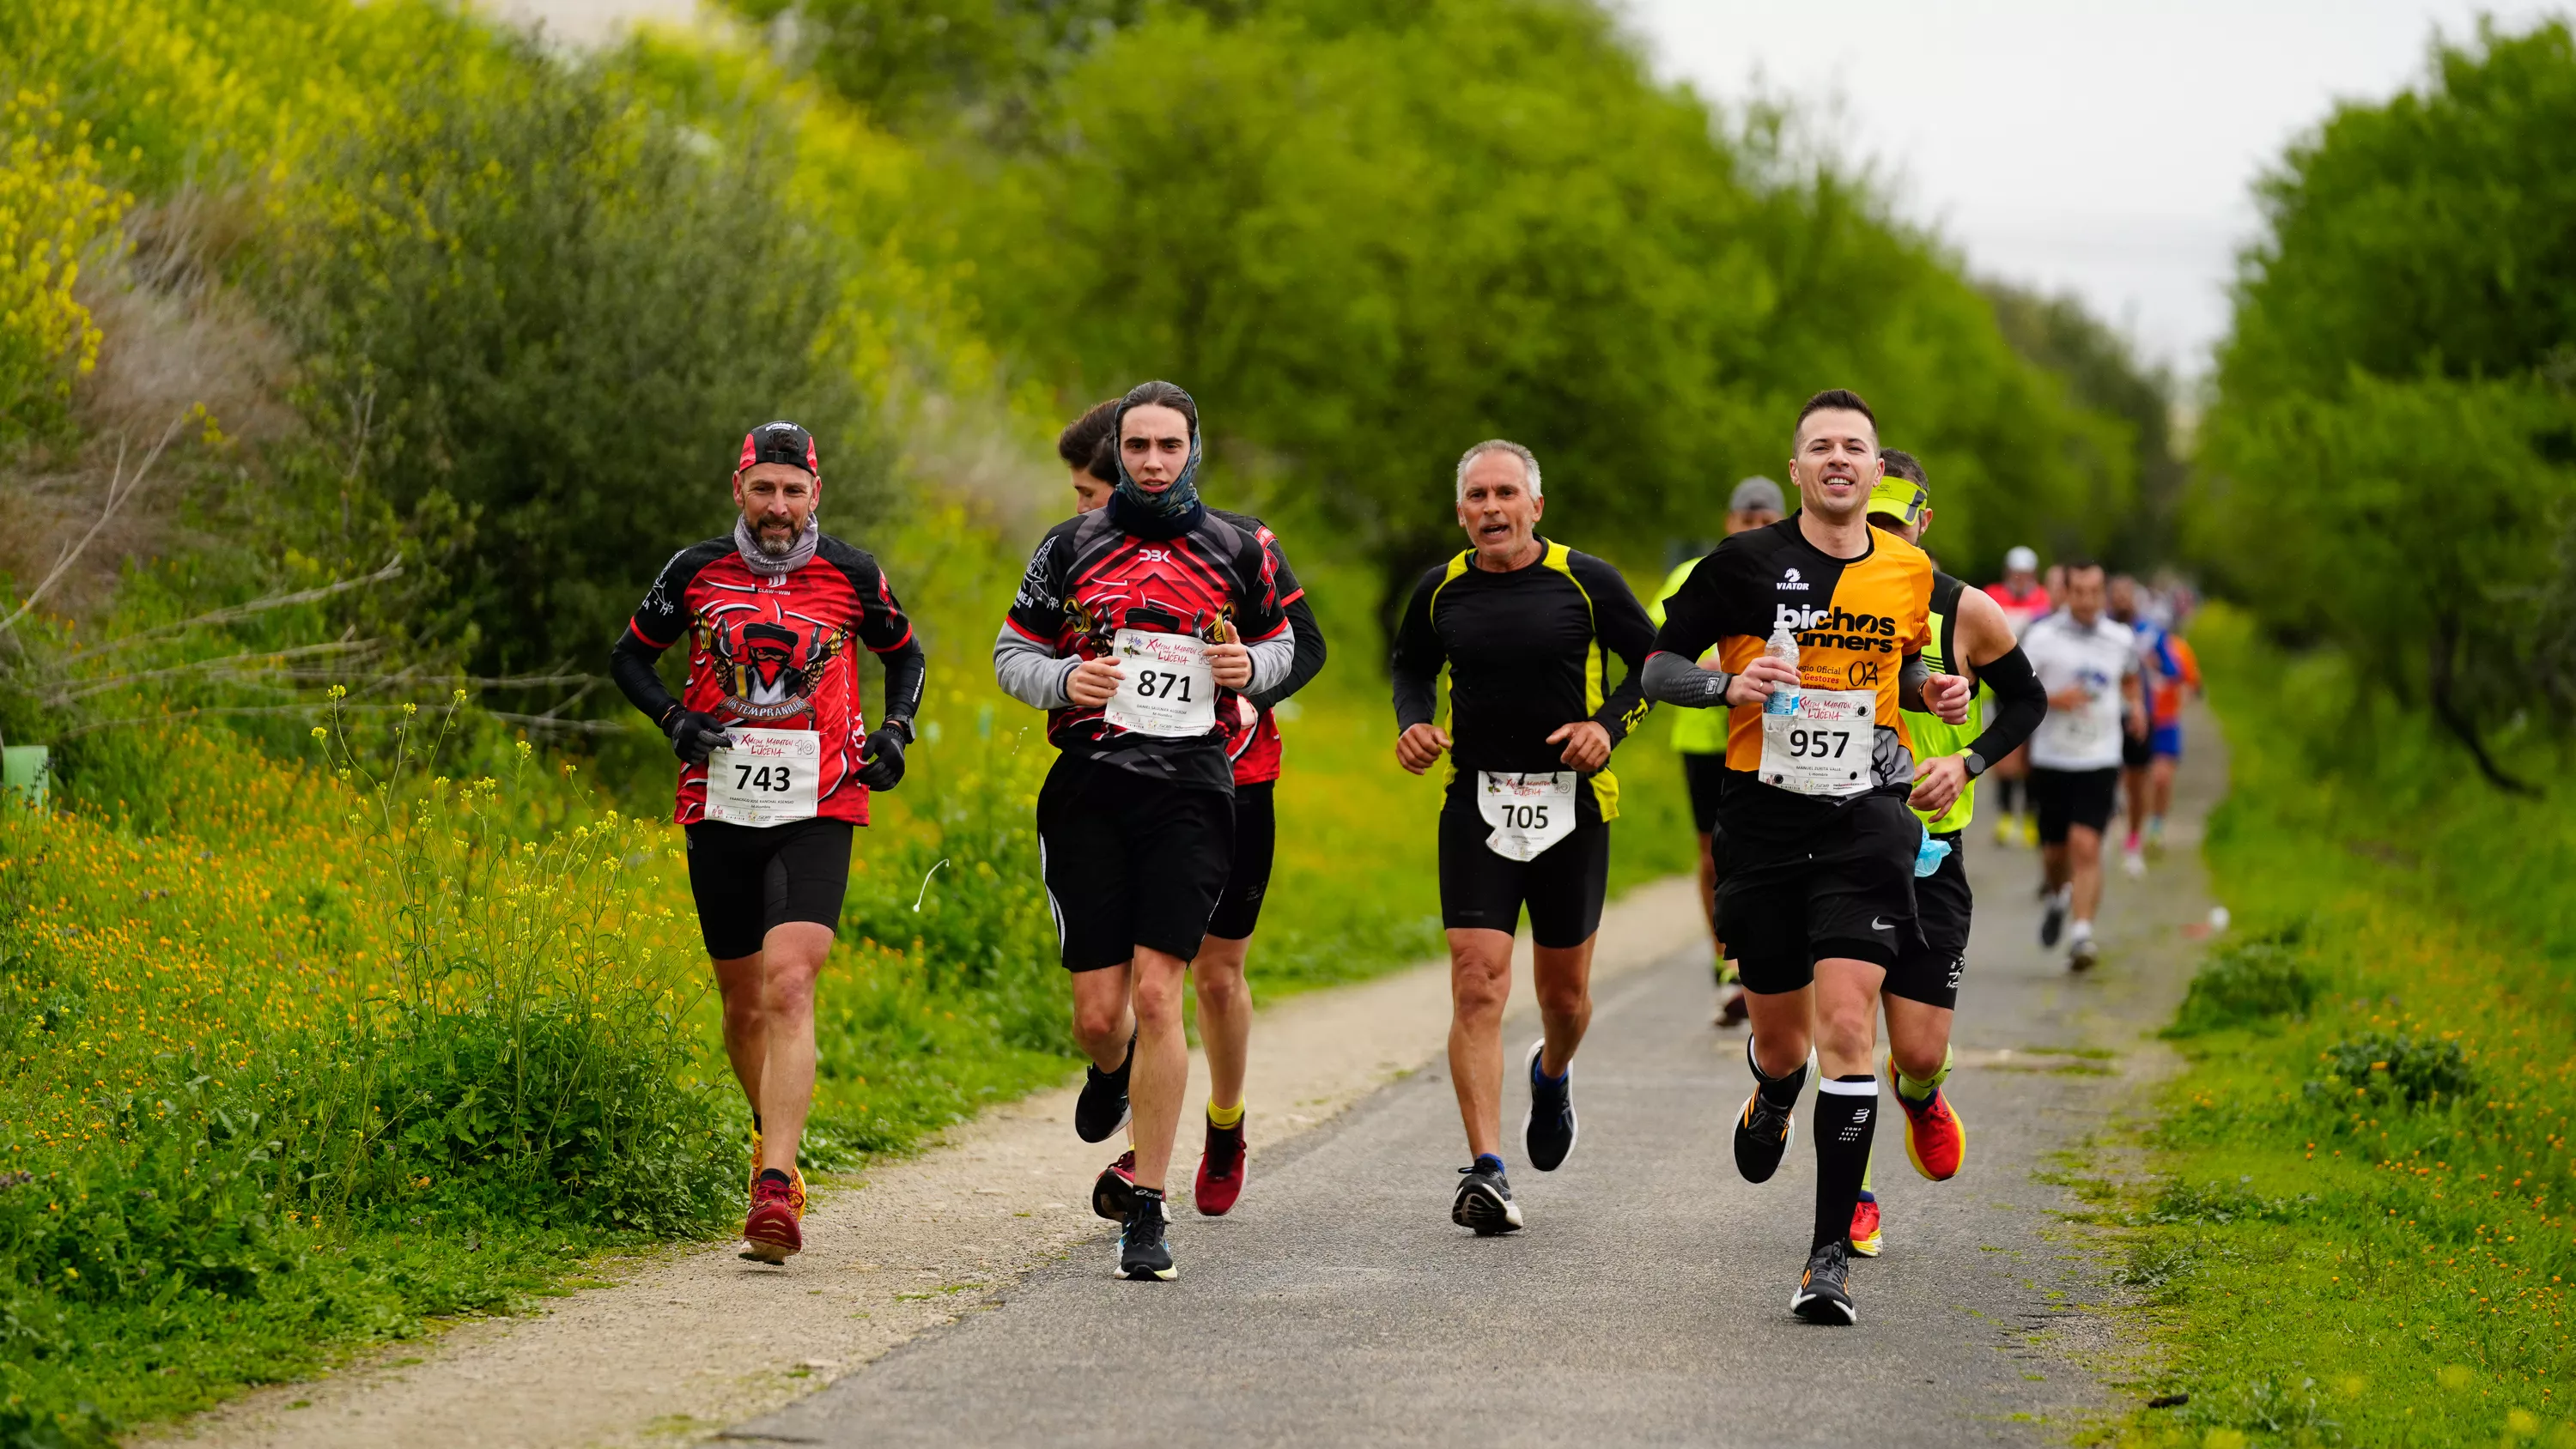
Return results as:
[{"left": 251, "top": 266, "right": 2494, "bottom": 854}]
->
[{"left": 729, "top": 716, "right": 2223, "bottom": 1449}]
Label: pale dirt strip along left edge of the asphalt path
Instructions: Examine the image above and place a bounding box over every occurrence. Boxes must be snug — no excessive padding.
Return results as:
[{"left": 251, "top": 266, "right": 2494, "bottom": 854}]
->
[{"left": 149, "top": 877, "right": 1703, "bottom": 1449}]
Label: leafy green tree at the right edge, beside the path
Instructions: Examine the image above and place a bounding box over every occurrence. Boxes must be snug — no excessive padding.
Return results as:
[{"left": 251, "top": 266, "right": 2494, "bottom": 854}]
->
[{"left": 2190, "top": 21, "right": 2576, "bottom": 787}]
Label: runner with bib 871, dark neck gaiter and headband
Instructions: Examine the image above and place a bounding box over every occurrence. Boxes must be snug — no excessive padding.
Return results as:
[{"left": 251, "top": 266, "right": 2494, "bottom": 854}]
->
[{"left": 992, "top": 381, "right": 1296, "bottom": 1279}]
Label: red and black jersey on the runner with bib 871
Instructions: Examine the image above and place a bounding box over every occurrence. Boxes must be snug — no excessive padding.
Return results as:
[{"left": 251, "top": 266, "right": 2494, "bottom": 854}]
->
[{"left": 1007, "top": 507, "right": 1288, "bottom": 790}]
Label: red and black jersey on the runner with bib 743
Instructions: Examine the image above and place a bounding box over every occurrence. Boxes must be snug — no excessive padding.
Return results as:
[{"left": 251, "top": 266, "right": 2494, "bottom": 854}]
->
[{"left": 626, "top": 536, "right": 912, "bottom": 826}]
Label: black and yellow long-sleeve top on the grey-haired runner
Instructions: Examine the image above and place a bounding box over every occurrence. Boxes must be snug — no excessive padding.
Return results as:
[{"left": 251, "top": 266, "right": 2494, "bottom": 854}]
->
[{"left": 1388, "top": 538, "right": 1654, "bottom": 821}]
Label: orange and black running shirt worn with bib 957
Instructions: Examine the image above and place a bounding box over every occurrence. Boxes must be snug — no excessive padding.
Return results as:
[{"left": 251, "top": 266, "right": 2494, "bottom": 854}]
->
[{"left": 1654, "top": 515, "right": 1932, "bottom": 839}]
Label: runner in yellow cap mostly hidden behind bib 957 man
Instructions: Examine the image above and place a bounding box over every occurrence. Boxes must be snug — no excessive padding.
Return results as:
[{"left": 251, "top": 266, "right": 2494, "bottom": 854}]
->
[{"left": 1852, "top": 448, "right": 2048, "bottom": 1258}]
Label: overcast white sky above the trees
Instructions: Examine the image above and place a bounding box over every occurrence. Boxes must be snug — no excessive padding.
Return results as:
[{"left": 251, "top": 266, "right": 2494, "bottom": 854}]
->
[{"left": 1625, "top": 0, "right": 2566, "bottom": 373}]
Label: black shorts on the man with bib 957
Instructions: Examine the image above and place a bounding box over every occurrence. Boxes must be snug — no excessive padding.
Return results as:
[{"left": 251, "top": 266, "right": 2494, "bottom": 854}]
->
[{"left": 1718, "top": 795, "right": 1922, "bottom": 996}]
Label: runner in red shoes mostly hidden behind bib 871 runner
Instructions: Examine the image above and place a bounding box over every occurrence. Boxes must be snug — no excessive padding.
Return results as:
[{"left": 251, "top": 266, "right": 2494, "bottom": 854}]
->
[{"left": 1056, "top": 399, "right": 1324, "bottom": 1222}]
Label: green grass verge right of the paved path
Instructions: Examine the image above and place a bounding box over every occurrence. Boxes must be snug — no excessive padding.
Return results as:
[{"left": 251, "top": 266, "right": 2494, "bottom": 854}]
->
[{"left": 2105, "top": 615, "right": 2576, "bottom": 1446}]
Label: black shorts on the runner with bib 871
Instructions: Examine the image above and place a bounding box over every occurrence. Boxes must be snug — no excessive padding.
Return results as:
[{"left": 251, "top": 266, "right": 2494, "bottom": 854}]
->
[{"left": 1038, "top": 754, "right": 1234, "bottom": 970}]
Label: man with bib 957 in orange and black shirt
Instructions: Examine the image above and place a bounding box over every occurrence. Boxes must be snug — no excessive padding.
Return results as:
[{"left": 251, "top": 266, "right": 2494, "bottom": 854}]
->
[{"left": 1646, "top": 389, "right": 1968, "bottom": 1323}]
